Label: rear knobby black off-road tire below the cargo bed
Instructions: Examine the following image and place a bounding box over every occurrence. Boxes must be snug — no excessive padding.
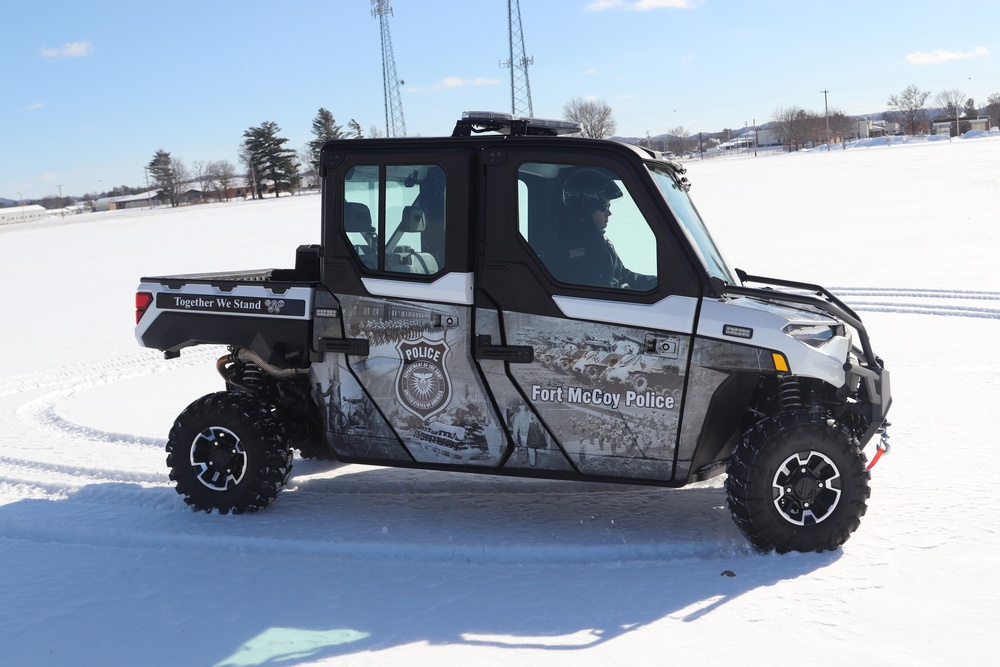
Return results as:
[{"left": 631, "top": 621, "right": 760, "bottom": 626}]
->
[{"left": 167, "top": 391, "right": 292, "bottom": 514}]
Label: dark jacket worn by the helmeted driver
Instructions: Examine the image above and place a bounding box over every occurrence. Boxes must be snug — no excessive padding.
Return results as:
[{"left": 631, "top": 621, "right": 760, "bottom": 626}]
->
[{"left": 545, "top": 221, "right": 656, "bottom": 290}]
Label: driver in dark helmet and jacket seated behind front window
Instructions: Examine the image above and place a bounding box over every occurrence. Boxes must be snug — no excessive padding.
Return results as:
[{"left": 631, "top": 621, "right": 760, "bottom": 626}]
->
[{"left": 550, "top": 169, "right": 656, "bottom": 290}]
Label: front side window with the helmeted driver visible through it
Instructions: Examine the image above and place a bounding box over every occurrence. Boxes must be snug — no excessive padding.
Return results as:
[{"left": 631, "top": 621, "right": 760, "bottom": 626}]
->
[{"left": 518, "top": 162, "right": 657, "bottom": 291}]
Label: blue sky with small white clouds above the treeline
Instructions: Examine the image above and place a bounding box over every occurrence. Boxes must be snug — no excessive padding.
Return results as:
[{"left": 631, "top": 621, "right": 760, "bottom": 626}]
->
[{"left": 0, "top": 0, "right": 1000, "bottom": 199}]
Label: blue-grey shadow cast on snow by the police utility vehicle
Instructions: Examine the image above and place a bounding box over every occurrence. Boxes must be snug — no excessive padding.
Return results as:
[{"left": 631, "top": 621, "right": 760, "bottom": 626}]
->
[{"left": 0, "top": 472, "right": 840, "bottom": 666}]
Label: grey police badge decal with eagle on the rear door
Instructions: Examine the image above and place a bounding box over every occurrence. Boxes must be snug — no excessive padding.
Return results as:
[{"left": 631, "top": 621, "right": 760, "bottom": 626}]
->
[{"left": 396, "top": 337, "right": 451, "bottom": 421}]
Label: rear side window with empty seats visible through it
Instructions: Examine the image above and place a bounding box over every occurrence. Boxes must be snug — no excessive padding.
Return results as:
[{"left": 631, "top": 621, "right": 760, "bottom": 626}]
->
[{"left": 344, "top": 165, "right": 446, "bottom": 275}]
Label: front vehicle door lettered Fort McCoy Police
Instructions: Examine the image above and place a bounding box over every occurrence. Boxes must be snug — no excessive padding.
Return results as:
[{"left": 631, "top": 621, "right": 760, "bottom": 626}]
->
[{"left": 475, "top": 145, "right": 700, "bottom": 481}]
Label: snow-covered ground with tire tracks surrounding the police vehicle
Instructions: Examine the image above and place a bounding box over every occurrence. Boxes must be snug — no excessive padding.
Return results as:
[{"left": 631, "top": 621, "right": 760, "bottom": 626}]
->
[{"left": 0, "top": 137, "right": 1000, "bottom": 666}]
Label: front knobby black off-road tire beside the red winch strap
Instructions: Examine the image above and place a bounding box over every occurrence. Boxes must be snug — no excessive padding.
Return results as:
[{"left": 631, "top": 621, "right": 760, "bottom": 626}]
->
[{"left": 726, "top": 412, "right": 871, "bottom": 553}]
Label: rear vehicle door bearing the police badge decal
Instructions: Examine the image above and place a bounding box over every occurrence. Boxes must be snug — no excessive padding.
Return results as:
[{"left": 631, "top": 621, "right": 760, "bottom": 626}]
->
[{"left": 312, "top": 142, "right": 506, "bottom": 466}]
